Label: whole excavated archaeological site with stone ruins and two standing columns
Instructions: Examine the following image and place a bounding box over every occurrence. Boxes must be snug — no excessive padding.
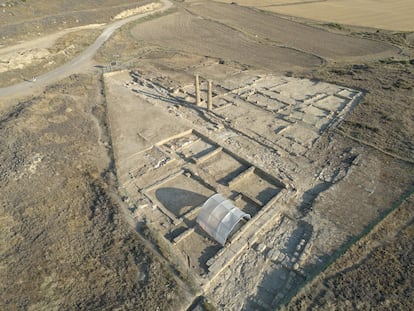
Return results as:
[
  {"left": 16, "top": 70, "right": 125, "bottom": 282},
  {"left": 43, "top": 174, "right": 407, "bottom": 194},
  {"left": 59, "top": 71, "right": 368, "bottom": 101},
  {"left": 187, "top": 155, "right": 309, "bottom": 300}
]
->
[{"left": 104, "top": 63, "right": 384, "bottom": 310}]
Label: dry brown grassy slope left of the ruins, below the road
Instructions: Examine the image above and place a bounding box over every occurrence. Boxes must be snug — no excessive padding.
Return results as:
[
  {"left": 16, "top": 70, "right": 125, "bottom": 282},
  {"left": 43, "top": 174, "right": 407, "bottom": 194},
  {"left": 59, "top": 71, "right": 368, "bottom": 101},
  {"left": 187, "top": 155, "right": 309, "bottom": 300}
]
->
[{"left": 0, "top": 75, "right": 181, "bottom": 310}]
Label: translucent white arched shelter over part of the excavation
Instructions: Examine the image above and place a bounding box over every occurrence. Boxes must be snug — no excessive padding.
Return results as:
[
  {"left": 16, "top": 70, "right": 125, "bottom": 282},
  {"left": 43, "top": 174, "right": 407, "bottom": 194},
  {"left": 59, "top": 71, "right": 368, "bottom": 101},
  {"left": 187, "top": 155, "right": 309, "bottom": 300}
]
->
[{"left": 196, "top": 193, "right": 251, "bottom": 245}]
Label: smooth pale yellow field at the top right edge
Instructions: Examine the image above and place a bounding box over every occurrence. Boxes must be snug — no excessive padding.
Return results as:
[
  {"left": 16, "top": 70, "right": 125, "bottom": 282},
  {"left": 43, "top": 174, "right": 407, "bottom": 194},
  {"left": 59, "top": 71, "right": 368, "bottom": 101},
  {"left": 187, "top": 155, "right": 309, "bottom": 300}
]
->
[{"left": 219, "top": 0, "right": 414, "bottom": 31}]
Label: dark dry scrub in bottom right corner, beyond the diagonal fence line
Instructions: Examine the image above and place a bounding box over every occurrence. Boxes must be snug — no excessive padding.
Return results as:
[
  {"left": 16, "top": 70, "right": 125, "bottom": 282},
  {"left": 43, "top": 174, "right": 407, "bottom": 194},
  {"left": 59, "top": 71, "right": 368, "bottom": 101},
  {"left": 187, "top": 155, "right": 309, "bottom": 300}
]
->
[{"left": 282, "top": 195, "right": 414, "bottom": 310}]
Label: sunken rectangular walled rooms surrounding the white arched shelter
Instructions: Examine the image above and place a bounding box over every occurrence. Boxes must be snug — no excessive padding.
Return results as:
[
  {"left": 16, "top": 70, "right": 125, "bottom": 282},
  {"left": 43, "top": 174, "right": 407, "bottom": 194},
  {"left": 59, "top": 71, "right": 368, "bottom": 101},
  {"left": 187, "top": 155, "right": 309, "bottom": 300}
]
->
[{"left": 125, "top": 127, "right": 284, "bottom": 276}]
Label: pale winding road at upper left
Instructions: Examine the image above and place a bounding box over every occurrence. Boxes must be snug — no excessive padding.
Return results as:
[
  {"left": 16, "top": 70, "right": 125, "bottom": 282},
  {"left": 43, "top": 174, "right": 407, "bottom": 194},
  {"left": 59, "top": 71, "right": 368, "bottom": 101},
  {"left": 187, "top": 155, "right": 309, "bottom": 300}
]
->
[{"left": 0, "top": 0, "right": 173, "bottom": 98}]
